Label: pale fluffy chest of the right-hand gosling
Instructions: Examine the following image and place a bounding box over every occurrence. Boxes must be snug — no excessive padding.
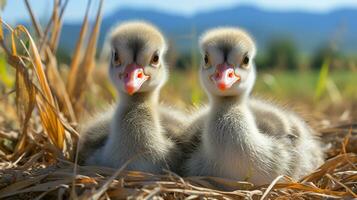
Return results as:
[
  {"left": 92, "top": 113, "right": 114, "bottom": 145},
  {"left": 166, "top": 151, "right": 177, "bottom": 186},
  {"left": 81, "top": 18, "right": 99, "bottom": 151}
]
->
[{"left": 203, "top": 109, "right": 274, "bottom": 184}]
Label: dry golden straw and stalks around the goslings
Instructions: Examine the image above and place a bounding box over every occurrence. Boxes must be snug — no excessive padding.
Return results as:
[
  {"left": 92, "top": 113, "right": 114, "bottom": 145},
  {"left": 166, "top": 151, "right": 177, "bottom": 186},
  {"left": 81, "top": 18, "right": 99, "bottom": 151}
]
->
[{"left": 0, "top": 0, "right": 357, "bottom": 199}]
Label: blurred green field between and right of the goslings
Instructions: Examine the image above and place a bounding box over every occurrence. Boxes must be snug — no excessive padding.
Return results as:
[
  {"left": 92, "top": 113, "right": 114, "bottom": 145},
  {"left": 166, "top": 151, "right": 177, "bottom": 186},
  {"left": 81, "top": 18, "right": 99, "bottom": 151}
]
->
[{"left": 162, "top": 68, "right": 357, "bottom": 108}]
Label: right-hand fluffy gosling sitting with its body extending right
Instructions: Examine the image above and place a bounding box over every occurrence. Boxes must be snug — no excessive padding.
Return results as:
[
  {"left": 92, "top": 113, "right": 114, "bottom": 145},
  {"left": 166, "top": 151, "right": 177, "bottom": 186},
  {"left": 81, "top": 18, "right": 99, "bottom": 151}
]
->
[{"left": 187, "top": 28, "right": 323, "bottom": 185}]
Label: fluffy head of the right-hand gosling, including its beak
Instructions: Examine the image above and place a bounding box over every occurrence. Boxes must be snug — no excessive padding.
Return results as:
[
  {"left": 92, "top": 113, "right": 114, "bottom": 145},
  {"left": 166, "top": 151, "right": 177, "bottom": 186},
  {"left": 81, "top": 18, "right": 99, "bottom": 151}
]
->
[{"left": 200, "top": 28, "right": 256, "bottom": 97}]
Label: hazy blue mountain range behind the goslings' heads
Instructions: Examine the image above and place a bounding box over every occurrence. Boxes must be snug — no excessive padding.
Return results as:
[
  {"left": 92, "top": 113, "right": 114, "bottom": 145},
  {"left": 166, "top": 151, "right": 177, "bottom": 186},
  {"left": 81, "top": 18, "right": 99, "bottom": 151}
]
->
[{"left": 61, "top": 6, "right": 357, "bottom": 53}]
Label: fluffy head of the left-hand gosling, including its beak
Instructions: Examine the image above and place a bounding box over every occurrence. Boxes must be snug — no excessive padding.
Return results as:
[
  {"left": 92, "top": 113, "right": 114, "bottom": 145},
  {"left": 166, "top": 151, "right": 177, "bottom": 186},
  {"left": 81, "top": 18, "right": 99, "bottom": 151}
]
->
[{"left": 109, "top": 21, "right": 167, "bottom": 95}]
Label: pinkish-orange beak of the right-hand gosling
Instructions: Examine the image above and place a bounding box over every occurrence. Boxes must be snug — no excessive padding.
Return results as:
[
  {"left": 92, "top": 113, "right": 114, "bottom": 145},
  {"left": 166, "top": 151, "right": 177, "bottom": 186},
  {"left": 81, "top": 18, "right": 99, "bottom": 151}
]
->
[{"left": 211, "top": 64, "right": 240, "bottom": 91}]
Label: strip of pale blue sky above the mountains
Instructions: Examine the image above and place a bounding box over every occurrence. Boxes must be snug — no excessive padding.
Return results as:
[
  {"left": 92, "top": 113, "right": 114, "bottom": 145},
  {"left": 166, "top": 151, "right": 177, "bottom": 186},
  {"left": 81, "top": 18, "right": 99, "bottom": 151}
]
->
[{"left": 1, "top": 0, "right": 357, "bottom": 23}]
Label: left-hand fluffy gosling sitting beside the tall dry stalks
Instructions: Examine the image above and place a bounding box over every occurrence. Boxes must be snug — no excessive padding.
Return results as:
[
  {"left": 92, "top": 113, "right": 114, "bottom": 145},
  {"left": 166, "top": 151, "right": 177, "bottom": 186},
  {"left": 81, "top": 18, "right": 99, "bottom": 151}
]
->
[{"left": 79, "top": 22, "right": 184, "bottom": 173}]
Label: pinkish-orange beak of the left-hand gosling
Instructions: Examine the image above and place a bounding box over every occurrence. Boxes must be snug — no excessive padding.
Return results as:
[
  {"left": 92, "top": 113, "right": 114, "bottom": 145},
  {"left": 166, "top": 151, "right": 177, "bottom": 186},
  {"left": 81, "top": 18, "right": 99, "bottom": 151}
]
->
[{"left": 124, "top": 64, "right": 149, "bottom": 95}]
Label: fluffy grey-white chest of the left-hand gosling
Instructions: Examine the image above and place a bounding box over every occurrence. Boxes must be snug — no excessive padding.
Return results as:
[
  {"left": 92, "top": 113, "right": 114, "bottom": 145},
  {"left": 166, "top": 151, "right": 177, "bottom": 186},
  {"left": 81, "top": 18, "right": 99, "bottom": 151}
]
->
[{"left": 92, "top": 110, "right": 175, "bottom": 173}]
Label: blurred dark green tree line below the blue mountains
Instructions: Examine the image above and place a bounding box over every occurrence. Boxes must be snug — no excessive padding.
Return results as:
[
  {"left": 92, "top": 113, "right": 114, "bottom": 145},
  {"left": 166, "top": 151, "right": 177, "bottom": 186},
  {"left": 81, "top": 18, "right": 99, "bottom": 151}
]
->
[{"left": 167, "top": 38, "right": 357, "bottom": 70}]
